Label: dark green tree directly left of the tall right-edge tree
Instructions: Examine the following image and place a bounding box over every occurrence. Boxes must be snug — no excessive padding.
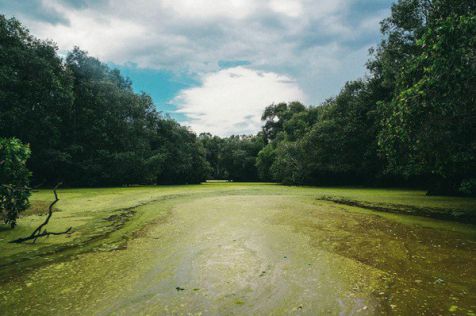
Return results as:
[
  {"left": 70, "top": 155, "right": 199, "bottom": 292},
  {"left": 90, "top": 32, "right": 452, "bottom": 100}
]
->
[{"left": 302, "top": 80, "right": 381, "bottom": 184}]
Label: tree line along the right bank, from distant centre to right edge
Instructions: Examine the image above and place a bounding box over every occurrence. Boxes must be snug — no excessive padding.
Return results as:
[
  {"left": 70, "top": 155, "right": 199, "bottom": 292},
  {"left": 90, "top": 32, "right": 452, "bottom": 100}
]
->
[{"left": 202, "top": 0, "right": 476, "bottom": 195}]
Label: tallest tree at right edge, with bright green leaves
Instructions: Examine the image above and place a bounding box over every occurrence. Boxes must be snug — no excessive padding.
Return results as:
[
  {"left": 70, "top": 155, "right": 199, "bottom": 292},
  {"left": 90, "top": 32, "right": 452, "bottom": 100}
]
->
[{"left": 379, "top": 1, "right": 476, "bottom": 194}]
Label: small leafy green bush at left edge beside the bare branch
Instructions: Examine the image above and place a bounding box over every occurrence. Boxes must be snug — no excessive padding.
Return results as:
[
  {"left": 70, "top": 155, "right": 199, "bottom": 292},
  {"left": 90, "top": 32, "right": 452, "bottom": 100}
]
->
[{"left": 0, "top": 138, "right": 31, "bottom": 228}]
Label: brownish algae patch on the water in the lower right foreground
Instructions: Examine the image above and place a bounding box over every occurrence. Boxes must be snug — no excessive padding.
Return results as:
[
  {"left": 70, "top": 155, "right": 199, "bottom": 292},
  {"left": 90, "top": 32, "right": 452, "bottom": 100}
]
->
[{"left": 272, "top": 198, "right": 476, "bottom": 314}]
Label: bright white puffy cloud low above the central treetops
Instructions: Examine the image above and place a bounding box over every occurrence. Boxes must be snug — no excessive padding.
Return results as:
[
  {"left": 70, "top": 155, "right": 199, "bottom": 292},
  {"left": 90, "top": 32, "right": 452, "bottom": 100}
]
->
[{"left": 175, "top": 66, "right": 305, "bottom": 136}]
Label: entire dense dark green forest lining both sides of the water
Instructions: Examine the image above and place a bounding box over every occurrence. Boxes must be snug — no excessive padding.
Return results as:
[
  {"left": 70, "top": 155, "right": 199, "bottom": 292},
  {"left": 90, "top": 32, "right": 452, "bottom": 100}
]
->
[{"left": 0, "top": 0, "right": 476, "bottom": 222}]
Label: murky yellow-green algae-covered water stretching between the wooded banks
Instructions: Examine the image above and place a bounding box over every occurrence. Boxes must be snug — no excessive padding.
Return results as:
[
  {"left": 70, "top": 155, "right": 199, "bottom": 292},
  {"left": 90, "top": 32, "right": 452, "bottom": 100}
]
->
[{"left": 0, "top": 184, "right": 476, "bottom": 315}]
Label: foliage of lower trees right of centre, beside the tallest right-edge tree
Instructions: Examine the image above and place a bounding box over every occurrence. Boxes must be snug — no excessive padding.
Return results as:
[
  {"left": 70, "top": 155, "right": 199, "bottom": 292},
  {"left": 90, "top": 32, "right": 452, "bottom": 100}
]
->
[{"left": 257, "top": 94, "right": 379, "bottom": 184}]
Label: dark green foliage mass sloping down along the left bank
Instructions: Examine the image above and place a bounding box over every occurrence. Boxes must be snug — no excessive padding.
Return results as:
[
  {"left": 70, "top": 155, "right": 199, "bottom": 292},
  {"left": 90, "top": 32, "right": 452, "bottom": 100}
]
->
[{"left": 0, "top": 15, "right": 209, "bottom": 186}]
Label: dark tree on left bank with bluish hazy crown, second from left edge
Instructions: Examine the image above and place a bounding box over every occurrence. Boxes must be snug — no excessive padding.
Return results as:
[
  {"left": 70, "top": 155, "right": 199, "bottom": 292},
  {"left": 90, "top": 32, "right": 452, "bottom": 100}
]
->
[{"left": 63, "top": 48, "right": 160, "bottom": 186}]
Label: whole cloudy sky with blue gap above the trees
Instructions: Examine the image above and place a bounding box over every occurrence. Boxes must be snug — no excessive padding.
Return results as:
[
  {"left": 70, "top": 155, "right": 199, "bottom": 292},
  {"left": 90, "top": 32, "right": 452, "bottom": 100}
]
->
[{"left": 0, "top": 0, "right": 393, "bottom": 136}]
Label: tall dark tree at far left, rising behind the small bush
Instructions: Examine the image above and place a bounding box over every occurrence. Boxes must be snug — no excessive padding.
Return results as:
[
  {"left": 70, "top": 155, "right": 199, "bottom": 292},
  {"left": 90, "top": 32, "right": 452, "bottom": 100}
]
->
[{"left": 0, "top": 15, "right": 73, "bottom": 182}]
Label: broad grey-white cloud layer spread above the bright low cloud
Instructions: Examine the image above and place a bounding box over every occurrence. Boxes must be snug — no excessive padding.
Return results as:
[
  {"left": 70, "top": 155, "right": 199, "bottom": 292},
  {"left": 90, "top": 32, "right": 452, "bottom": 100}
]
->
[{"left": 6, "top": 0, "right": 393, "bottom": 124}]
